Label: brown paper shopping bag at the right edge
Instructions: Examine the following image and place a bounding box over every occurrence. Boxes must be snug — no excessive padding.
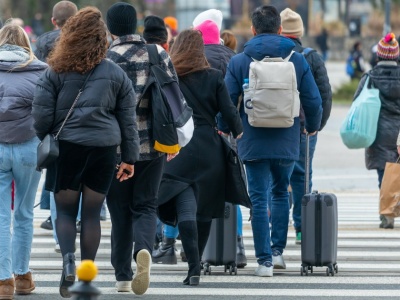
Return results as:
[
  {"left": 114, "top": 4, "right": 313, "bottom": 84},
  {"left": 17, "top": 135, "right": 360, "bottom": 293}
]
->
[{"left": 379, "top": 157, "right": 400, "bottom": 218}]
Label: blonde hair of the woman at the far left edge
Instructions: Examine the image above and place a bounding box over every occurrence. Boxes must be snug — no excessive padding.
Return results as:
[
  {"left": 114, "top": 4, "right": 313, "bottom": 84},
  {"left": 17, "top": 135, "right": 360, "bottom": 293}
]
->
[{"left": 0, "top": 20, "right": 36, "bottom": 68}]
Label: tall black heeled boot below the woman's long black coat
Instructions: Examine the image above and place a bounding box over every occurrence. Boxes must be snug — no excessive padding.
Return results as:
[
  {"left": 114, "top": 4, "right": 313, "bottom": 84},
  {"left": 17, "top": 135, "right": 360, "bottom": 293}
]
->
[{"left": 178, "top": 221, "right": 200, "bottom": 285}]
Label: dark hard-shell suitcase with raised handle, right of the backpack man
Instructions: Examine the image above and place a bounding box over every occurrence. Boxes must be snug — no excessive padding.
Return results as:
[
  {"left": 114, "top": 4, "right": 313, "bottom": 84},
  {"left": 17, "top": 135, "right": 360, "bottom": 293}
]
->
[{"left": 300, "top": 135, "right": 338, "bottom": 276}]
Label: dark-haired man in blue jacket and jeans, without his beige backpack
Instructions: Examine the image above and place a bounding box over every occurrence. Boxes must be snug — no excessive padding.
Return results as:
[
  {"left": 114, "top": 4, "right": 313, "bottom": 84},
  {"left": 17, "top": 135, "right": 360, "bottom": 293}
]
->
[{"left": 220, "top": 5, "right": 322, "bottom": 277}]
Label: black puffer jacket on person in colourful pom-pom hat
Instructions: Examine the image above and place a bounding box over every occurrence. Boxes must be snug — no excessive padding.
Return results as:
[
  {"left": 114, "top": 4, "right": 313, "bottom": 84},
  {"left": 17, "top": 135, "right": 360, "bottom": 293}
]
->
[{"left": 354, "top": 61, "right": 400, "bottom": 170}]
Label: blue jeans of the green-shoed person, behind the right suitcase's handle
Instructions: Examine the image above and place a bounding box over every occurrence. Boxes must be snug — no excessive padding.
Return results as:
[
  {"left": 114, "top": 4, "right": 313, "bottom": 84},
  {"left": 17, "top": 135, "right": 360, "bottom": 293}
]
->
[{"left": 290, "top": 134, "right": 317, "bottom": 232}]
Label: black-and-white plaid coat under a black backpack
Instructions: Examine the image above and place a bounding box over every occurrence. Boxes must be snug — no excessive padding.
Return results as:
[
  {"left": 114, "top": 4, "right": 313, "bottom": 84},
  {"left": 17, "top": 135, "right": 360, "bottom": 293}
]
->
[{"left": 107, "top": 34, "right": 177, "bottom": 161}]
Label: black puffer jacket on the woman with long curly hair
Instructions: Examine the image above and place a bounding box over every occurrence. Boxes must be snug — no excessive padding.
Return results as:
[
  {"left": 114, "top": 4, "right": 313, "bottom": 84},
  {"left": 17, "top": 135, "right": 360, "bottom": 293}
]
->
[{"left": 32, "top": 60, "right": 139, "bottom": 164}]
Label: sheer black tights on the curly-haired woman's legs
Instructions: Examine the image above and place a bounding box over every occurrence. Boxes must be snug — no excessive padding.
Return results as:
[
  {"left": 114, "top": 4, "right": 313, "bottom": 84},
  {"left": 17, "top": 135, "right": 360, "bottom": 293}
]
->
[{"left": 54, "top": 185, "right": 105, "bottom": 260}]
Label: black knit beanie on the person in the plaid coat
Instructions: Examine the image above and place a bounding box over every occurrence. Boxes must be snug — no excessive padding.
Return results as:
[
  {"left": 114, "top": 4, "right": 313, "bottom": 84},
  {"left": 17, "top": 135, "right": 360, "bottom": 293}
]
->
[{"left": 107, "top": 2, "right": 137, "bottom": 36}]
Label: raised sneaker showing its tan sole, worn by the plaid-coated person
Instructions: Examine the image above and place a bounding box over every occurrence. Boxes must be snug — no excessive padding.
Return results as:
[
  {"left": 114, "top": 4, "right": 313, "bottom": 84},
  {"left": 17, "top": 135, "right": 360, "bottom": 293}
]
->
[{"left": 131, "top": 249, "right": 151, "bottom": 295}]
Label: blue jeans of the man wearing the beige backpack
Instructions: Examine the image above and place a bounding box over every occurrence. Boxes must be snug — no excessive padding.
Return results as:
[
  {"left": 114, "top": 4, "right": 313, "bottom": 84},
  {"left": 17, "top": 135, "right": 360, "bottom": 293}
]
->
[{"left": 245, "top": 159, "right": 294, "bottom": 265}]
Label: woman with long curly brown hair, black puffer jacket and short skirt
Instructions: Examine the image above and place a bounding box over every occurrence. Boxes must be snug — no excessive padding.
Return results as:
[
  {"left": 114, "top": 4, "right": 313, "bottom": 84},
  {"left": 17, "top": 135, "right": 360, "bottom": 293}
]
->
[{"left": 32, "top": 7, "right": 139, "bottom": 297}]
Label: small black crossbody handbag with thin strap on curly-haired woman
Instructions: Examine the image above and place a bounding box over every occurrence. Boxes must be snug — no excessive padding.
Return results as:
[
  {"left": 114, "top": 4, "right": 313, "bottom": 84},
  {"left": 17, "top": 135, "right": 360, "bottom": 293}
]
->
[{"left": 36, "top": 68, "right": 94, "bottom": 171}]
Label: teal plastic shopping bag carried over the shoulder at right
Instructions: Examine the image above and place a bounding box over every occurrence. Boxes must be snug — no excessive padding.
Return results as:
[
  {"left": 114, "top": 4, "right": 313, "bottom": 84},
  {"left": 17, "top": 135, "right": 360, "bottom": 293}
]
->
[{"left": 340, "top": 75, "right": 381, "bottom": 149}]
